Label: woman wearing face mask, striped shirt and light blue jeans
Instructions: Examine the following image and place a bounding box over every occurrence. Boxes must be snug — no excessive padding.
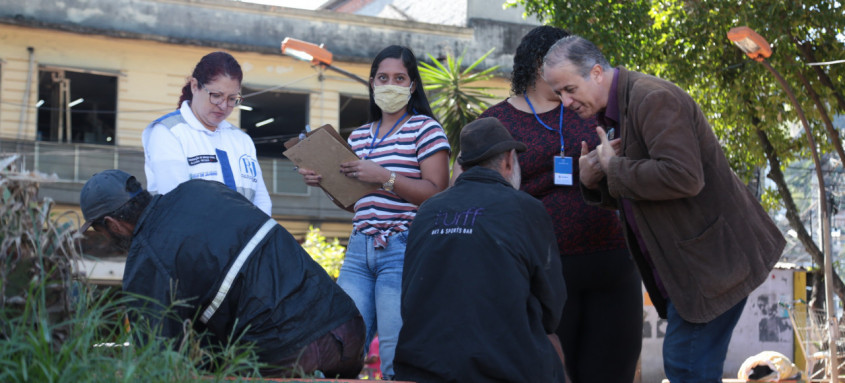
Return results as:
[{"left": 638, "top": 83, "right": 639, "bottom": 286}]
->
[{"left": 299, "top": 45, "right": 449, "bottom": 379}]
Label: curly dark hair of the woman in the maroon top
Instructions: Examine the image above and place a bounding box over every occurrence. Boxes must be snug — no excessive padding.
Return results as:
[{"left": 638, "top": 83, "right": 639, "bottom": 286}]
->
[{"left": 511, "top": 25, "right": 569, "bottom": 95}]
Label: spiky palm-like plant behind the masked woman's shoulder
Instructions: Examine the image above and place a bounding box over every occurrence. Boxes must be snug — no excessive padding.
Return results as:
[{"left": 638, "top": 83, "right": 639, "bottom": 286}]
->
[{"left": 419, "top": 48, "right": 499, "bottom": 158}]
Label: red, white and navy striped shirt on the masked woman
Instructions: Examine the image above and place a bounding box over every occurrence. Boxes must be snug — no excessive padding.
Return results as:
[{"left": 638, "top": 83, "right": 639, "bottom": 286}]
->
[{"left": 348, "top": 115, "right": 449, "bottom": 248}]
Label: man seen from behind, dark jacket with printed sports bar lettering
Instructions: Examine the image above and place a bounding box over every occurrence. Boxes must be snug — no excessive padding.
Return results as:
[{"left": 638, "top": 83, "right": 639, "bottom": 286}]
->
[{"left": 394, "top": 117, "right": 566, "bottom": 383}]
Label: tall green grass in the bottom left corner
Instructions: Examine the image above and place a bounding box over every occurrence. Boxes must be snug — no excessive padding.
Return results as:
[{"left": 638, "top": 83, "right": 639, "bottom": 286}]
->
[{"left": 0, "top": 284, "right": 261, "bottom": 382}]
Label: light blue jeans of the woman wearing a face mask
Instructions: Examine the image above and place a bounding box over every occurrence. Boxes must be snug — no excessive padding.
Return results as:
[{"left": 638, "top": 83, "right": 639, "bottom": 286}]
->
[{"left": 337, "top": 231, "right": 408, "bottom": 378}]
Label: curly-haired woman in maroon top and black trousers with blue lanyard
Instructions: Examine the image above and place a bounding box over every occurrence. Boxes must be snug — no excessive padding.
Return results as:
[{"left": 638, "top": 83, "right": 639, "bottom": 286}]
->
[{"left": 474, "top": 26, "right": 643, "bottom": 383}]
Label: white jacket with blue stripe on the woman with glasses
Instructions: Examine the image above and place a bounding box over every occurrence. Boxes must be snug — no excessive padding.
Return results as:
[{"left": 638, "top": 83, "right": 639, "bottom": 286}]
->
[{"left": 141, "top": 101, "right": 272, "bottom": 215}]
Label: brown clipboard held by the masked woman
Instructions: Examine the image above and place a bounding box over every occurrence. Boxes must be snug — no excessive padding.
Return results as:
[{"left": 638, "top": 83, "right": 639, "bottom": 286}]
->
[{"left": 282, "top": 125, "right": 381, "bottom": 208}]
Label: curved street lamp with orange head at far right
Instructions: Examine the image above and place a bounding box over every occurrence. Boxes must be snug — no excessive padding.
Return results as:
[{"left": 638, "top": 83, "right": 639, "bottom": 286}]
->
[{"left": 728, "top": 26, "right": 839, "bottom": 383}]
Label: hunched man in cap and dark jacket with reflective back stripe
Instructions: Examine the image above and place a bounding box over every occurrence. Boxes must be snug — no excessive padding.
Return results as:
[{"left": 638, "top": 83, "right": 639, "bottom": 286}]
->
[{"left": 80, "top": 170, "right": 364, "bottom": 378}]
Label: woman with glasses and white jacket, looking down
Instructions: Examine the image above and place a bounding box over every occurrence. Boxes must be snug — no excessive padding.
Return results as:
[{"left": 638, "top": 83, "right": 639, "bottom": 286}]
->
[{"left": 142, "top": 52, "right": 271, "bottom": 215}]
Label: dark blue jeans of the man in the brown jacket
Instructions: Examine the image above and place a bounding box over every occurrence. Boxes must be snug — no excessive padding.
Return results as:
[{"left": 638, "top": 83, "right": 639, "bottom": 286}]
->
[{"left": 663, "top": 298, "right": 748, "bottom": 383}]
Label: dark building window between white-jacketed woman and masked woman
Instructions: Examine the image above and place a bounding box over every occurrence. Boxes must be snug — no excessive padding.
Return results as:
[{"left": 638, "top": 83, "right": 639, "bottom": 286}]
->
[{"left": 241, "top": 87, "right": 308, "bottom": 158}]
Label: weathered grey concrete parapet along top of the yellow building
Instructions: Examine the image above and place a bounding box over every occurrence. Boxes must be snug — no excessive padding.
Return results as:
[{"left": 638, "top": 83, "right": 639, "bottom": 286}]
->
[{"left": 0, "top": 0, "right": 533, "bottom": 70}]
